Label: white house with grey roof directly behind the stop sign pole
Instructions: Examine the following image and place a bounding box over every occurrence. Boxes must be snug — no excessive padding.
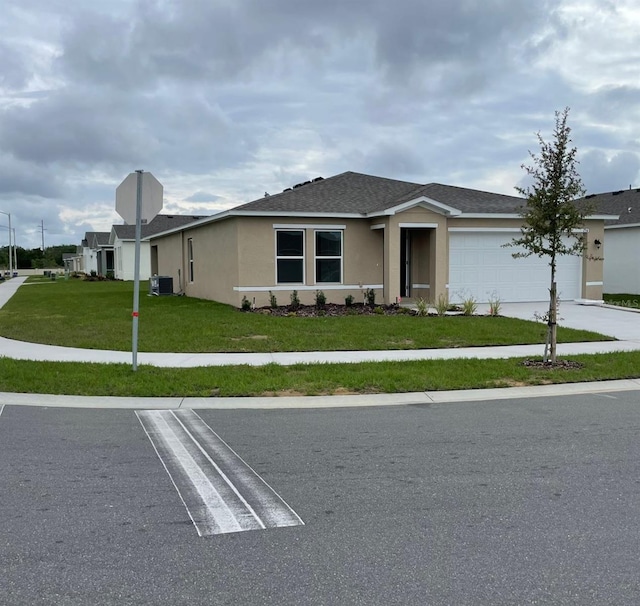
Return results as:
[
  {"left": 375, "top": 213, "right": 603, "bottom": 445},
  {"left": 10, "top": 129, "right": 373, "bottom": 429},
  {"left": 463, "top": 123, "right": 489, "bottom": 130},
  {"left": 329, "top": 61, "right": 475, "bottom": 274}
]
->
[{"left": 109, "top": 215, "right": 203, "bottom": 280}]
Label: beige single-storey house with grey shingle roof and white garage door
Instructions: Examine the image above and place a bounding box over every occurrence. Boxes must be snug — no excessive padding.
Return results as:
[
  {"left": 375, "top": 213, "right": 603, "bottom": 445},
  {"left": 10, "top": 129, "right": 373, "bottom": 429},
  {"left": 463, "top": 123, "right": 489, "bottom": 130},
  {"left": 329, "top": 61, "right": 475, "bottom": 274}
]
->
[{"left": 150, "top": 172, "right": 615, "bottom": 306}]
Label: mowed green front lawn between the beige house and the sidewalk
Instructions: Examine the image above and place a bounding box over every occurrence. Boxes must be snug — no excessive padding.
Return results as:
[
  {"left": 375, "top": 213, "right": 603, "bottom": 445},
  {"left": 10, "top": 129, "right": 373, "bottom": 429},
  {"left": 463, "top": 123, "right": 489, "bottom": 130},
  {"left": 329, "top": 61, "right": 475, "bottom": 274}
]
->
[{"left": 0, "top": 279, "right": 608, "bottom": 353}]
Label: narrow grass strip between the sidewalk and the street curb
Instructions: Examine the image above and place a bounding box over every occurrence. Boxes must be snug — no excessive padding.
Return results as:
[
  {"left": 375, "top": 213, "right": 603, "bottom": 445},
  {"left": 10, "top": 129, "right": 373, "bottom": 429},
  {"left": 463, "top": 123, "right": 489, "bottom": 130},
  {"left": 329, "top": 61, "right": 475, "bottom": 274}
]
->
[{"left": 0, "top": 352, "right": 640, "bottom": 397}]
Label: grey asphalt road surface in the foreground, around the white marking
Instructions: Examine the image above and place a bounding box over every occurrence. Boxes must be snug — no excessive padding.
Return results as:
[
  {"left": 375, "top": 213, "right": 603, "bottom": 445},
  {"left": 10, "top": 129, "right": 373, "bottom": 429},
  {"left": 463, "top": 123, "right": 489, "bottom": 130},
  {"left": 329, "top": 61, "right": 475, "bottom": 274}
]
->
[{"left": 0, "top": 392, "right": 640, "bottom": 606}]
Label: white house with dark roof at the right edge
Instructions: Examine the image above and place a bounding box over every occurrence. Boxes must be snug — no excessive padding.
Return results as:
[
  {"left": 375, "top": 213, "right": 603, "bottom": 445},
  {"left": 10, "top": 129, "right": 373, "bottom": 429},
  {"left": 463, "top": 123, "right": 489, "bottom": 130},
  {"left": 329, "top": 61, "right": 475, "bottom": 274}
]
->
[{"left": 586, "top": 188, "right": 640, "bottom": 295}]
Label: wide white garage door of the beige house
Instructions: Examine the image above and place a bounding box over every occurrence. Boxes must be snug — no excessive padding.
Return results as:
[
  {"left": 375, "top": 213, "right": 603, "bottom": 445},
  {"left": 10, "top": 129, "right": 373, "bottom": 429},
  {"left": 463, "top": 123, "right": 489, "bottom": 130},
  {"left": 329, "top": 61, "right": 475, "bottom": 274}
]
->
[{"left": 449, "top": 231, "right": 582, "bottom": 303}]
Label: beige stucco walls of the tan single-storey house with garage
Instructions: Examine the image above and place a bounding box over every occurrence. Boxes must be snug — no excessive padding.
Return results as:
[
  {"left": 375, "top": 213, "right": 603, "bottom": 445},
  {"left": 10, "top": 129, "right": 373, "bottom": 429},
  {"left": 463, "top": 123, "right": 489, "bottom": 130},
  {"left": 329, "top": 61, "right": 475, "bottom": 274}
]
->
[{"left": 152, "top": 213, "right": 604, "bottom": 307}]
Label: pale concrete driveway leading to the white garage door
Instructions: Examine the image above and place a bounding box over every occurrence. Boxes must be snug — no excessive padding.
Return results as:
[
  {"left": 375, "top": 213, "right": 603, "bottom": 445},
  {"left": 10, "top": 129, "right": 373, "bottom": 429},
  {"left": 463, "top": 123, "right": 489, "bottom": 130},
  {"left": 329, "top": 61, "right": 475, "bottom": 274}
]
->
[{"left": 488, "top": 301, "right": 640, "bottom": 341}]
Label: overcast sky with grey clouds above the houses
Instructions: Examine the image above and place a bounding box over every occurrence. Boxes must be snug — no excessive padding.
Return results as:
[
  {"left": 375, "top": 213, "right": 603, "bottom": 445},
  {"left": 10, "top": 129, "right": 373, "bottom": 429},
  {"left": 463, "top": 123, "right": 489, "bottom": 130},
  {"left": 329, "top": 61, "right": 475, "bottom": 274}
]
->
[{"left": 0, "top": 0, "right": 640, "bottom": 248}]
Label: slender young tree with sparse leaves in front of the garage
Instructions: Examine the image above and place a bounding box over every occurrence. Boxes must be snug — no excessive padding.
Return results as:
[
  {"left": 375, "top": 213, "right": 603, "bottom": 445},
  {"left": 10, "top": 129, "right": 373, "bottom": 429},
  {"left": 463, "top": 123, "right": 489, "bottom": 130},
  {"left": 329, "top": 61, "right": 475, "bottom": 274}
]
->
[{"left": 508, "top": 107, "right": 591, "bottom": 363}]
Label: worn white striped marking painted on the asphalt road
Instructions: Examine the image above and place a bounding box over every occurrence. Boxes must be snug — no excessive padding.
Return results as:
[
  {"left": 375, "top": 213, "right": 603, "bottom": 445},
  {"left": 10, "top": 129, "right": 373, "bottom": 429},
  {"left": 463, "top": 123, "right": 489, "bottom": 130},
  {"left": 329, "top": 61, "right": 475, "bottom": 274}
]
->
[{"left": 136, "top": 409, "right": 304, "bottom": 536}]
